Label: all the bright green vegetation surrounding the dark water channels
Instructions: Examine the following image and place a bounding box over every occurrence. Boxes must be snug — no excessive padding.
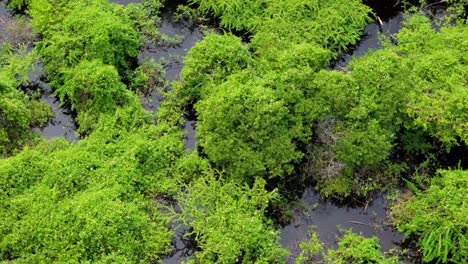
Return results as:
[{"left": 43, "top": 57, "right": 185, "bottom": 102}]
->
[{"left": 0, "top": 0, "right": 468, "bottom": 263}]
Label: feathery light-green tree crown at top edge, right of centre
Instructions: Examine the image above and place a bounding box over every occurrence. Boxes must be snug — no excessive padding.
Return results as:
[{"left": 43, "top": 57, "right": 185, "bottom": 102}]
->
[{"left": 252, "top": 0, "right": 370, "bottom": 58}]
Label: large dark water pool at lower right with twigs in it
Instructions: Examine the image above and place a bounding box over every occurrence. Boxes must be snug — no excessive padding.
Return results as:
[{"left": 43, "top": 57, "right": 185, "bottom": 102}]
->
[{"left": 280, "top": 189, "right": 404, "bottom": 263}]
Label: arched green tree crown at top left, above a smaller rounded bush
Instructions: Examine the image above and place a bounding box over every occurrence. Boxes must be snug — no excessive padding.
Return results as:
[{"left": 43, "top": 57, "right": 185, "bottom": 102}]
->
[{"left": 31, "top": 2, "right": 139, "bottom": 85}]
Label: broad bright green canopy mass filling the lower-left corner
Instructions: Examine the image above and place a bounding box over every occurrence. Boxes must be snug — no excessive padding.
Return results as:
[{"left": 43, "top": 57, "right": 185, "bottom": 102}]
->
[{"left": 0, "top": 119, "right": 188, "bottom": 263}]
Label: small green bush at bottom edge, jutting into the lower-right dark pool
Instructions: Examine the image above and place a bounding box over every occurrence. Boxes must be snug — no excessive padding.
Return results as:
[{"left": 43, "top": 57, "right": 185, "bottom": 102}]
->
[{"left": 325, "top": 229, "right": 400, "bottom": 264}]
